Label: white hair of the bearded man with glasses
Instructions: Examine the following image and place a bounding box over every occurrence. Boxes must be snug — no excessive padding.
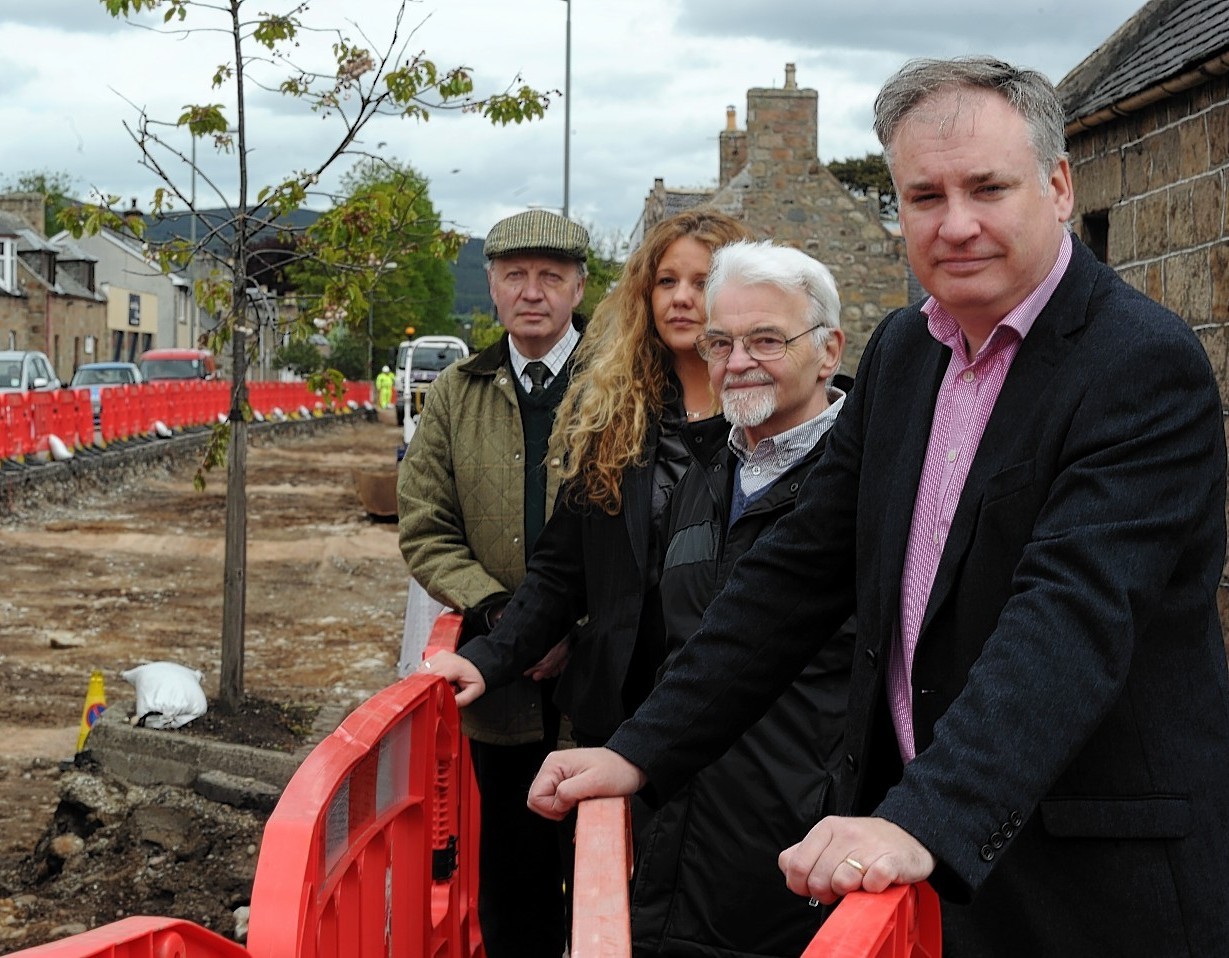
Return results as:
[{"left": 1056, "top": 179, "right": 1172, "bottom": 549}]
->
[{"left": 704, "top": 240, "right": 841, "bottom": 349}]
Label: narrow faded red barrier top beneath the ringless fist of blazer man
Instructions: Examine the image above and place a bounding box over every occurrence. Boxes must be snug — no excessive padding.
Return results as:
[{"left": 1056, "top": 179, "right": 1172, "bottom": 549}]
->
[{"left": 571, "top": 798, "right": 632, "bottom": 958}]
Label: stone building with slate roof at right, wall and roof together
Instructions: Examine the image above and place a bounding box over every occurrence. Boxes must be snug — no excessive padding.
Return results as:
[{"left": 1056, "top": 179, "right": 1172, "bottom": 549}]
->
[{"left": 1058, "top": 0, "right": 1229, "bottom": 635}]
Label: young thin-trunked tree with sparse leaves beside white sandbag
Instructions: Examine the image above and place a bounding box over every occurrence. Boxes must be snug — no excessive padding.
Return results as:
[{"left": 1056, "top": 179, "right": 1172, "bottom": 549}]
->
[{"left": 65, "top": 0, "right": 548, "bottom": 710}]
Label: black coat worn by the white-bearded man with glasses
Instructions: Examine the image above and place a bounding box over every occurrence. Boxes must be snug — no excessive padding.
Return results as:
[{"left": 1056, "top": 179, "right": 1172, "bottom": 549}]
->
[{"left": 632, "top": 418, "right": 854, "bottom": 958}]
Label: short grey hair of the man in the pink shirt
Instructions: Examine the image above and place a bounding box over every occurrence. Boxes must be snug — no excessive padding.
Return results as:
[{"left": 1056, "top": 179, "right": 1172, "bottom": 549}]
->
[{"left": 875, "top": 57, "right": 1067, "bottom": 186}]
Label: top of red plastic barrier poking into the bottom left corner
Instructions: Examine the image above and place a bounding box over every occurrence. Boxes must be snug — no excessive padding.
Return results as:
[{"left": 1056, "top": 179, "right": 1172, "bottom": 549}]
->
[{"left": 10, "top": 917, "right": 251, "bottom": 958}]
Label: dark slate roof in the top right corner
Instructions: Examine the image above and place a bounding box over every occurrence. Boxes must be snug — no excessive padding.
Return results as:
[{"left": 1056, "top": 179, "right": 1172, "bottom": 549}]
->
[{"left": 1058, "top": 0, "right": 1229, "bottom": 123}]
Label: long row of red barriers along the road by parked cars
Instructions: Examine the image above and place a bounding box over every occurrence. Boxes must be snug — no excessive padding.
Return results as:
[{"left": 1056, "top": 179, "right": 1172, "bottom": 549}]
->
[{"left": 0, "top": 380, "right": 371, "bottom": 462}]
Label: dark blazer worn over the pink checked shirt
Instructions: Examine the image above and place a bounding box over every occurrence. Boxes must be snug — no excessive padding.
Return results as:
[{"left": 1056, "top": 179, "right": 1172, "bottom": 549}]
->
[{"left": 611, "top": 236, "right": 1229, "bottom": 956}]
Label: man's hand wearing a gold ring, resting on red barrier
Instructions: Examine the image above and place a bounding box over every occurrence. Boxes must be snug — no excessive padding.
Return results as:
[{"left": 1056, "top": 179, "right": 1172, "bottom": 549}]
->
[{"left": 777, "top": 815, "right": 934, "bottom": 905}]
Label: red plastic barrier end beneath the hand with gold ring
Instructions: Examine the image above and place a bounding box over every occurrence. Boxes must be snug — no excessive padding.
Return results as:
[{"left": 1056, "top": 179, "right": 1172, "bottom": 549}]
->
[{"left": 803, "top": 882, "right": 943, "bottom": 958}]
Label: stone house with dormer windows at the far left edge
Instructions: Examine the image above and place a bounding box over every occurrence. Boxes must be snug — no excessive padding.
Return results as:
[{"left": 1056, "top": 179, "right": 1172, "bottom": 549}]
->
[{"left": 0, "top": 193, "right": 107, "bottom": 382}]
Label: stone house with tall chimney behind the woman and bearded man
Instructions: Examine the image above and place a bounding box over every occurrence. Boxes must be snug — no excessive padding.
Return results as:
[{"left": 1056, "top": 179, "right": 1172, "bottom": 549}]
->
[{"left": 632, "top": 64, "right": 908, "bottom": 373}]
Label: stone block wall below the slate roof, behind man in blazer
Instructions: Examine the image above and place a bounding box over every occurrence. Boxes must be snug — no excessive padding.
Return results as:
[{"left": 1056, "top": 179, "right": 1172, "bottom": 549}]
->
[{"left": 1068, "top": 76, "right": 1229, "bottom": 635}]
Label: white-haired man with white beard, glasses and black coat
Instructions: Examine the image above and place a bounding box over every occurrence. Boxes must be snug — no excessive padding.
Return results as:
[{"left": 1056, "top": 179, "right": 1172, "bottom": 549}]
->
[{"left": 632, "top": 236, "right": 854, "bottom": 958}]
